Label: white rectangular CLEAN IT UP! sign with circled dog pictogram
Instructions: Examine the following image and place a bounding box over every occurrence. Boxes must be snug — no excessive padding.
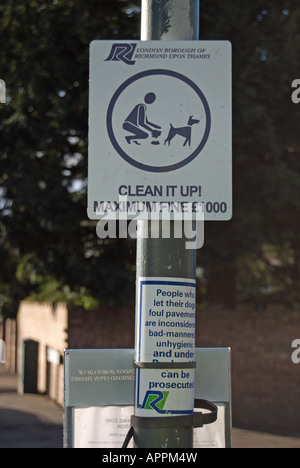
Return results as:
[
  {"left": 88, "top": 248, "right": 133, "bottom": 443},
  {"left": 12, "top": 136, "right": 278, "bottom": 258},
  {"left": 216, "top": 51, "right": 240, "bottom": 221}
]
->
[{"left": 88, "top": 41, "right": 232, "bottom": 220}]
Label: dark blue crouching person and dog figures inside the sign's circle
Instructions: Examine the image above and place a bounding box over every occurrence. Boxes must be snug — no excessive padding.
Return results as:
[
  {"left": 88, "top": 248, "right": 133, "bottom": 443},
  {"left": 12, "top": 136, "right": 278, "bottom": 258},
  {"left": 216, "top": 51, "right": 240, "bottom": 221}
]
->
[{"left": 123, "top": 92, "right": 200, "bottom": 146}]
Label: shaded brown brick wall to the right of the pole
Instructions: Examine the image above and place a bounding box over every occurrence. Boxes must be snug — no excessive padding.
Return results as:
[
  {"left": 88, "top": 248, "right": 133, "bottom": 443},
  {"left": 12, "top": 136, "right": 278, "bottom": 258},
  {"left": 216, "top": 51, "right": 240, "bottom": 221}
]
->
[{"left": 197, "top": 306, "right": 300, "bottom": 435}]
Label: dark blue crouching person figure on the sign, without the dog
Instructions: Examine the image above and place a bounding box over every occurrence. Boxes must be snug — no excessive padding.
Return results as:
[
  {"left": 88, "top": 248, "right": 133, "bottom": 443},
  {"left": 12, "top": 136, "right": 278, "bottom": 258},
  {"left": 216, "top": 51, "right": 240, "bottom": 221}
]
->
[{"left": 123, "top": 93, "right": 161, "bottom": 145}]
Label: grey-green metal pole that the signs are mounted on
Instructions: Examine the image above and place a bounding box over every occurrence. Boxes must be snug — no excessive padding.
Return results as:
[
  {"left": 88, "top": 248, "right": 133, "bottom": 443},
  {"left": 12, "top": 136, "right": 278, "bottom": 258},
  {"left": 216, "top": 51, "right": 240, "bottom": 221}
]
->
[{"left": 133, "top": 0, "right": 200, "bottom": 448}]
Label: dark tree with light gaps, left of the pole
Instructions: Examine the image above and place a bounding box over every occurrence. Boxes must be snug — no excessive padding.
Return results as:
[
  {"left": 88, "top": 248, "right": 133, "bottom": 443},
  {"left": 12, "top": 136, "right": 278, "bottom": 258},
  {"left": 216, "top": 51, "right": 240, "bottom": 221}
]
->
[{"left": 0, "top": 0, "right": 139, "bottom": 313}]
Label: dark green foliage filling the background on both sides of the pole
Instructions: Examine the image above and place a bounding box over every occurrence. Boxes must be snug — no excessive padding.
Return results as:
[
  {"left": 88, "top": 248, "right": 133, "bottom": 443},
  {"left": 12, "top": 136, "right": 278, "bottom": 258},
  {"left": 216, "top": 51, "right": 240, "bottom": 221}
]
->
[{"left": 0, "top": 0, "right": 300, "bottom": 316}]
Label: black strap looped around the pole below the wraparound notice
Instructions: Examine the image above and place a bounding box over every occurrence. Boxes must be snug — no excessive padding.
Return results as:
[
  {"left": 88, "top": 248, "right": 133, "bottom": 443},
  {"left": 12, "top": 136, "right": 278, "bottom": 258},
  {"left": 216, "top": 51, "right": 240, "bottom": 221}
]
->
[{"left": 122, "top": 400, "right": 218, "bottom": 448}]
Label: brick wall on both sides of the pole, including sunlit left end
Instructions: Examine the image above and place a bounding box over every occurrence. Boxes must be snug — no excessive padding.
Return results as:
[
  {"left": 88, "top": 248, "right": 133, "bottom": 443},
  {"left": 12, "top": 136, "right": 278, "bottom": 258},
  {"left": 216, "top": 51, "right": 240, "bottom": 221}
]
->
[{"left": 7, "top": 303, "right": 300, "bottom": 435}]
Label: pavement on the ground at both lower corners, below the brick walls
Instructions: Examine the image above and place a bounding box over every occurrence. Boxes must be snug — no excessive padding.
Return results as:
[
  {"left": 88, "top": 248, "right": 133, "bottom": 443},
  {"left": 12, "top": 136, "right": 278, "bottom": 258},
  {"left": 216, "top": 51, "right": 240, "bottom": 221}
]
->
[{"left": 0, "top": 364, "right": 300, "bottom": 448}]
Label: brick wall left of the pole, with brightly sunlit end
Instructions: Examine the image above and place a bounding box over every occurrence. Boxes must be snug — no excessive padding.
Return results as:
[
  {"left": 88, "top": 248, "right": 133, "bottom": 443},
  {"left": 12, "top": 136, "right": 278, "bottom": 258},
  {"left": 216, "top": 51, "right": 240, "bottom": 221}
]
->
[{"left": 17, "top": 302, "right": 134, "bottom": 405}]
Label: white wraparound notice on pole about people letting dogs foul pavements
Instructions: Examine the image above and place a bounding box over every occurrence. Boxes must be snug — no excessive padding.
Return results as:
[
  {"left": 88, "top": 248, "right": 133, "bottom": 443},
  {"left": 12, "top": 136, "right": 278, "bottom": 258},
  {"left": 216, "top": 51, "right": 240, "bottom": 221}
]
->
[{"left": 136, "top": 278, "right": 196, "bottom": 417}]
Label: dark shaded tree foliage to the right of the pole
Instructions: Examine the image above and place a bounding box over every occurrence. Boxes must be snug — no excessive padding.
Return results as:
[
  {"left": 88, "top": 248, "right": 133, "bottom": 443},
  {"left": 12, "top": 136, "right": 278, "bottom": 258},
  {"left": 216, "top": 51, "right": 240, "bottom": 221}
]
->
[{"left": 201, "top": 0, "right": 300, "bottom": 303}]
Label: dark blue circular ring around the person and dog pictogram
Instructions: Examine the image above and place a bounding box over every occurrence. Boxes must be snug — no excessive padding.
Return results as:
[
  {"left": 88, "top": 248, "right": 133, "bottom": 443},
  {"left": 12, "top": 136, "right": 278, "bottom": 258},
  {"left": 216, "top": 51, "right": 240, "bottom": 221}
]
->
[{"left": 106, "top": 69, "right": 211, "bottom": 172}]
